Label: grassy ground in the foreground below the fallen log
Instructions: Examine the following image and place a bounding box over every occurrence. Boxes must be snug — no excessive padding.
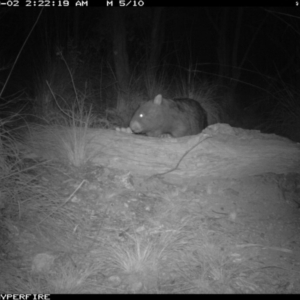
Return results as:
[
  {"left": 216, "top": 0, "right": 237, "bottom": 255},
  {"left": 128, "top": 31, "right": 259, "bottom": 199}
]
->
[{"left": 0, "top": 123, "right": 300, "bottom": 294}]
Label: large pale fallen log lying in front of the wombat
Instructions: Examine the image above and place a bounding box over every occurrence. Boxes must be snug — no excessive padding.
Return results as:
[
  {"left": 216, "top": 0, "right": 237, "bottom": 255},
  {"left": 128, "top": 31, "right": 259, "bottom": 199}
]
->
[{"left": 22, "top": 124, "right": 300, "bottom": 185}]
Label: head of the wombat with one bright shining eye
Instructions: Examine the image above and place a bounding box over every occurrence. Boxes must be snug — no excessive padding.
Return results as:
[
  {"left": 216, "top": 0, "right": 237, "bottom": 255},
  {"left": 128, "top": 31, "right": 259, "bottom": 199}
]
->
[{"left": 130, "top": 95, "right": 164, "bottom": 134}]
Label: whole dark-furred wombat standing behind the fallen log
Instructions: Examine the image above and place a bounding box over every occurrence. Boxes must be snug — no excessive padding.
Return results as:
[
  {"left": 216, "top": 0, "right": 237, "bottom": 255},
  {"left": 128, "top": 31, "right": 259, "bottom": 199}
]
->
[{"left": 130, "top": 95, "right": 207, "bottom": 137}]
